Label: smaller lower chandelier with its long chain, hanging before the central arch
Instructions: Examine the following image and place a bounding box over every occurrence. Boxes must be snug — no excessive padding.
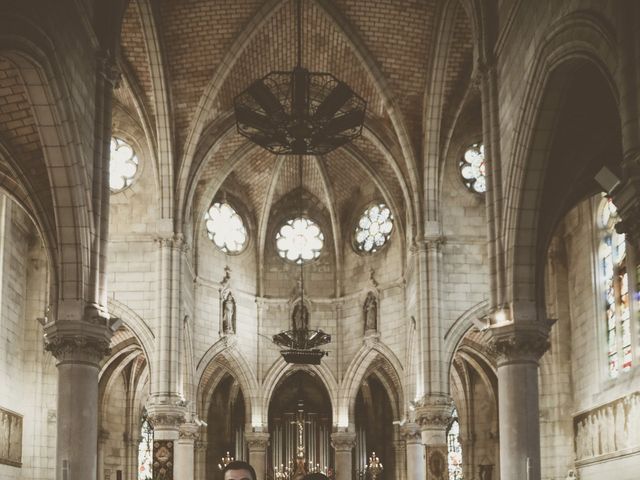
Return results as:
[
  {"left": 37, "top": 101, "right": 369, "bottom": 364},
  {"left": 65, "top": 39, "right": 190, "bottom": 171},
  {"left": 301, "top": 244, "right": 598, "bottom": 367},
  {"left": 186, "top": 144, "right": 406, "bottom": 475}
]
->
[{"left": 272, "top": 155, "right": 331, "bottom": 365}]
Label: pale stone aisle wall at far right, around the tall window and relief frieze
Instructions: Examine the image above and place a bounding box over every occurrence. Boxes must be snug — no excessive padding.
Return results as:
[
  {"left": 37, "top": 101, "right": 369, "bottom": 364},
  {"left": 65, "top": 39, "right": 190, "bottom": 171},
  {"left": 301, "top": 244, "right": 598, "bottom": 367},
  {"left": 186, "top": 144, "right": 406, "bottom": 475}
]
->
[{"left": 540, "top": 196, "right": 640, "bottom": 480}]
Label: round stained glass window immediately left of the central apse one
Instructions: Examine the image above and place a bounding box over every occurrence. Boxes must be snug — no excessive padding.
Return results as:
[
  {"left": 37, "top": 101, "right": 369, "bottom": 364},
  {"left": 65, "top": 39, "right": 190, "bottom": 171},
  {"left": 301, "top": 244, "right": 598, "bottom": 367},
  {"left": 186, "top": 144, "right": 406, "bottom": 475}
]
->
[{"left": 204, "top": 202, "right": 248, "bottom": 253}]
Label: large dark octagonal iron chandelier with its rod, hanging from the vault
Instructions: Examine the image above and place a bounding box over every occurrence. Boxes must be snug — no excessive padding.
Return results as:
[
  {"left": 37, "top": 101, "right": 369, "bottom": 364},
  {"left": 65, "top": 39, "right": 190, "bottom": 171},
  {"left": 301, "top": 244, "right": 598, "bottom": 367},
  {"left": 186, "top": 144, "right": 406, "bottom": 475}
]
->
[{"left": 234, "top": 0, "right": 367, "bottom": 155}]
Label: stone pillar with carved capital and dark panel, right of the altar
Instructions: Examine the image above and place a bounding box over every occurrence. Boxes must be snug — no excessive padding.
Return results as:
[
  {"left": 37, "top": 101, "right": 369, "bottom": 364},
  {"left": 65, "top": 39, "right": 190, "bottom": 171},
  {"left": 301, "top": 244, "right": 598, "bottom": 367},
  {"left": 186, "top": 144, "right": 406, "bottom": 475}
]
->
[{"left": 416, "top": 395, "right": 453, "bottom": 480}]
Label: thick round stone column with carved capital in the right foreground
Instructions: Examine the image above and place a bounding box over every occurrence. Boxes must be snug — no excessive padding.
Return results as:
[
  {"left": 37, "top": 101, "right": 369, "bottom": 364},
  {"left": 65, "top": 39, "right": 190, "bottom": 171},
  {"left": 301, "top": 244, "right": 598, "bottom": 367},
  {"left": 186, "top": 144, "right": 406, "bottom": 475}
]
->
[{"left": 489, "top": 321, "right": 550, "bottom": 480}]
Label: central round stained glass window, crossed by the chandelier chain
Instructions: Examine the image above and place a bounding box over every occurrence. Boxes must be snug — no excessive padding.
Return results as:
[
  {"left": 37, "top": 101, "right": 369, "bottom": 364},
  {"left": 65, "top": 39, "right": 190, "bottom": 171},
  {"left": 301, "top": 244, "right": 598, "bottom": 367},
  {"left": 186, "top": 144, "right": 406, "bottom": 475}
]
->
[{"left": 276, "top": 217, "right": 324, "bottom": 264}]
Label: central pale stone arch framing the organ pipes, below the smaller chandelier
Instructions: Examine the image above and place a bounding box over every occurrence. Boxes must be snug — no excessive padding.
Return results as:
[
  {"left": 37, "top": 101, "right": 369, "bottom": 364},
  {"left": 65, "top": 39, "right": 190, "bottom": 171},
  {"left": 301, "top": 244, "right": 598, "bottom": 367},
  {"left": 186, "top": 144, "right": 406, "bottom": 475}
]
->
[{"left": 261, "top": 357, "right": 338, "bottom": 425}]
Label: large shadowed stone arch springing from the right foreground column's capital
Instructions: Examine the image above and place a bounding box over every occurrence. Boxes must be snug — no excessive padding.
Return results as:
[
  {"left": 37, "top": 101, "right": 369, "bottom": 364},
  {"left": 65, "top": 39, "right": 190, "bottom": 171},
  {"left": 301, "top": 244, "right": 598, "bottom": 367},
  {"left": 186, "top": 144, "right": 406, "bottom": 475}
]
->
[{"left": 503, "top": 12, "right": 618, "bottom": 321}]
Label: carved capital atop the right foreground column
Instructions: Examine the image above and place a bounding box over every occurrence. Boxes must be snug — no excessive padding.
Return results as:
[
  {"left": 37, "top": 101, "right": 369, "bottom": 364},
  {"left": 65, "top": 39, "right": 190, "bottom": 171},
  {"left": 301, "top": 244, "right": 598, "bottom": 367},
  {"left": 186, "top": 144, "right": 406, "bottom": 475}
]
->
[{"left": 489, "top": 320, "right": 553, "bottom": 366}]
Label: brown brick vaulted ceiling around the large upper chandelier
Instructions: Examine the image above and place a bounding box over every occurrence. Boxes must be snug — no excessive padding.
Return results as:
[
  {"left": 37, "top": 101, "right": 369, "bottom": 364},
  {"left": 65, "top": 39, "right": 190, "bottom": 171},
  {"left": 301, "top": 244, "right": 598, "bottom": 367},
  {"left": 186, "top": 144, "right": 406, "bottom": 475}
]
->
[{"left": 116, "top": 0, "right": 472, "bottom": 237}]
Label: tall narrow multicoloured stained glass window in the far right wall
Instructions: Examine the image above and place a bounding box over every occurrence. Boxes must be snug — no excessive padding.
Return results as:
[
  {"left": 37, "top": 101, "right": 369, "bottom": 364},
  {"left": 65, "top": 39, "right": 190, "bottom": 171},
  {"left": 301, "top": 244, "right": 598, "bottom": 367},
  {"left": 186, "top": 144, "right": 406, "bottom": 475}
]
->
[{"left": 599, "top": 198, "right": 633, "bottom": 378}]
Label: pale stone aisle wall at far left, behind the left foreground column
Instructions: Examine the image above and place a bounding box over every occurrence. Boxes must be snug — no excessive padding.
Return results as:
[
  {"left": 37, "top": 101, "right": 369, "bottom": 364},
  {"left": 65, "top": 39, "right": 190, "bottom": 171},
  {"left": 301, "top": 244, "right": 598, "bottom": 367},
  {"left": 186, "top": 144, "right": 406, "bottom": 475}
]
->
[{"left": 0, "top": 195, "right": 57, "bottom": 480}]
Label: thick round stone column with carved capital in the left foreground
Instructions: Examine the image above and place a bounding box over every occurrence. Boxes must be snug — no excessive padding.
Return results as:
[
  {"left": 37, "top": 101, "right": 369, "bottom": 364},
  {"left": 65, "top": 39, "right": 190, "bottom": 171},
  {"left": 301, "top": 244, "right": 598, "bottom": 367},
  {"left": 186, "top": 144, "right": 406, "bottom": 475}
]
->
[{"left": 44, "top": 319, "right": 110, "bottom": 480}]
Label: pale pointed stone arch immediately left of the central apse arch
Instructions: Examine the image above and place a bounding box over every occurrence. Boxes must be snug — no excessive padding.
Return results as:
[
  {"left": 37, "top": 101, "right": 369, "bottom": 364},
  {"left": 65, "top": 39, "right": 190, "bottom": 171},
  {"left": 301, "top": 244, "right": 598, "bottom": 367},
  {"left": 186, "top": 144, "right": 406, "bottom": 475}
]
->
[{"left": 194, "top": 336, "right": 260, "bottom": 419}]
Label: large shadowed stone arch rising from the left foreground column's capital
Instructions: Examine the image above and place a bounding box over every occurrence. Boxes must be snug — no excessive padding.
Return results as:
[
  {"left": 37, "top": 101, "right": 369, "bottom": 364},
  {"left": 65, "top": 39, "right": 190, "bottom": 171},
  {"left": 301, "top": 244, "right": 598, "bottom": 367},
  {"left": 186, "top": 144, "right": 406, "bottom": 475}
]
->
[{"left": 0, "top": 15, "right": 92, "bottom": 310}]
